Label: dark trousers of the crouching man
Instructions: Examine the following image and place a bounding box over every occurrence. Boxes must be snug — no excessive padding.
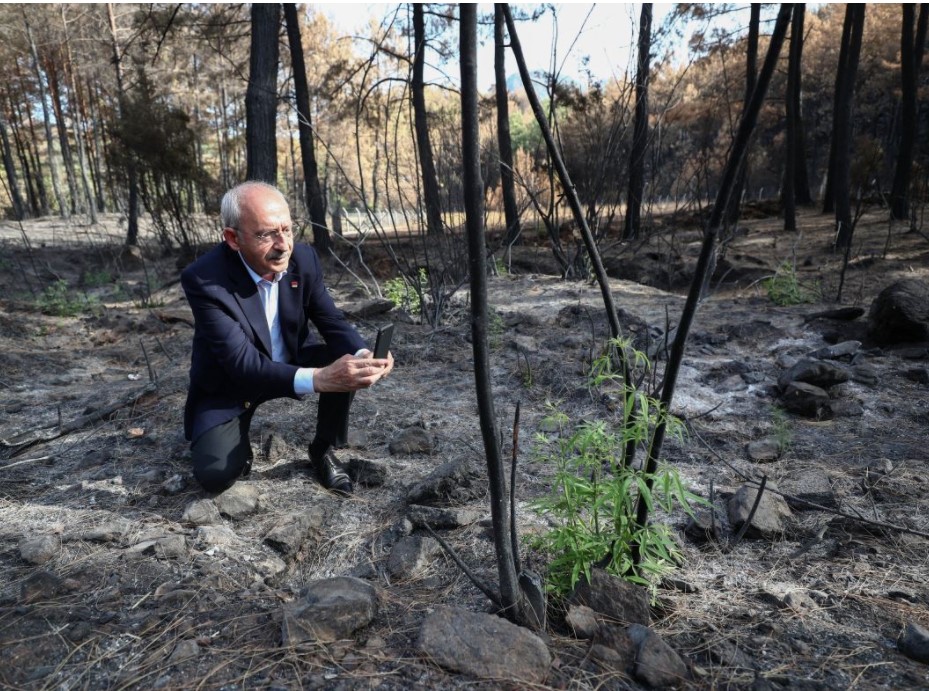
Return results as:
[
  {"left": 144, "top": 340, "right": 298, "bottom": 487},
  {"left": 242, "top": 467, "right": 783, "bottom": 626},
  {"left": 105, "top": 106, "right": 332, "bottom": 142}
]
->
[{"left": 190, "top": 393, "right": 354, "bottom": 493}]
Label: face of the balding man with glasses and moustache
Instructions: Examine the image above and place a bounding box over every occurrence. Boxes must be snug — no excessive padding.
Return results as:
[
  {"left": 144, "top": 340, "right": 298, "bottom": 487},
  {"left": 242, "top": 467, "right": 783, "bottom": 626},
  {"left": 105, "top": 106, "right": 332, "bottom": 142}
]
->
[{"left": 223, "top": 187, "right": 294, "bottom": 276}]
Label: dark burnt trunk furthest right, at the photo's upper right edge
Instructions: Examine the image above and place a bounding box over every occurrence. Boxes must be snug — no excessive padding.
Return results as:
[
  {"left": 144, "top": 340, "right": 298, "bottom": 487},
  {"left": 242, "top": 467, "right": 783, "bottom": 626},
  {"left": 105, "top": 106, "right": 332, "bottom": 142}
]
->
[{"left": 890, "top": 3, "right": 929, "bottom": 220}]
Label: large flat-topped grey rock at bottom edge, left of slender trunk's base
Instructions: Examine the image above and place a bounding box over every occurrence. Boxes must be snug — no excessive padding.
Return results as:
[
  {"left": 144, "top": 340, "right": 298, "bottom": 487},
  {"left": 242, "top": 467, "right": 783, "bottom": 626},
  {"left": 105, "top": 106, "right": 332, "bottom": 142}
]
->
[{"left": 418, "top": 608, "right": 552, "bottom": 684}]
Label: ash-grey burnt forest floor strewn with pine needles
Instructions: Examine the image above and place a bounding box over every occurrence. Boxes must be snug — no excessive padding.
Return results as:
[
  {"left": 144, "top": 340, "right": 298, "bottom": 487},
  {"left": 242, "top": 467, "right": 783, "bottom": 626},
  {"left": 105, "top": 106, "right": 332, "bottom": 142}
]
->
[{"left": 0, "top": 209, "right": 929, "bottom": 689}]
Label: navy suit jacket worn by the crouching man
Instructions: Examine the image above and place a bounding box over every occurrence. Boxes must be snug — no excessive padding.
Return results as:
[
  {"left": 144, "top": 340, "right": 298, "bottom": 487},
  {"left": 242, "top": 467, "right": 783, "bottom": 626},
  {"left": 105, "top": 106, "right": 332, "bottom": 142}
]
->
[{"left": 181, "top": 242, "right": 367, "bottom": 441}]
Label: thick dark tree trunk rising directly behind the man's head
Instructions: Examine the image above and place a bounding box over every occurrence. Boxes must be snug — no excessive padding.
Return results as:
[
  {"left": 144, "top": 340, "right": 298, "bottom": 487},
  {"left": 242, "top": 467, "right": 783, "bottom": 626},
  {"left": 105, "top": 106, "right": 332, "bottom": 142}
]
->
[{"left": 245, "top": 3, "right": 281, "bottom": 185}]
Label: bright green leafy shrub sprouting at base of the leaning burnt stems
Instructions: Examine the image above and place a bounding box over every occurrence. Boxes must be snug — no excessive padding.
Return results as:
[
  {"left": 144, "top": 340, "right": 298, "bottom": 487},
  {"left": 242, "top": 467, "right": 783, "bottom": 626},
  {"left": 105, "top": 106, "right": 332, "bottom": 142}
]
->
[{"left": 533, "top": 340, "right": 703, "bottom": 595}]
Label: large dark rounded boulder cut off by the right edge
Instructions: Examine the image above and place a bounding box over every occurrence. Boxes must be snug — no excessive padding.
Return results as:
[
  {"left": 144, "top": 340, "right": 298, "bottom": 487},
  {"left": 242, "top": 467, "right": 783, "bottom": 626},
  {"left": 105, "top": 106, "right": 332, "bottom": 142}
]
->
[{"left": 868, "top": 278, "right": 929, "bottom": 346}]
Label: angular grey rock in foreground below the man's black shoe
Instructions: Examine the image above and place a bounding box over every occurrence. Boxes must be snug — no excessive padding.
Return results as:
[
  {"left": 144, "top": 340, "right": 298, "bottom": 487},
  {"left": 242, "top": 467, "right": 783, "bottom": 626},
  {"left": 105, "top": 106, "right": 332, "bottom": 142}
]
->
[{"left": 282, "top": 576, "right": 377, "bottom": 645}]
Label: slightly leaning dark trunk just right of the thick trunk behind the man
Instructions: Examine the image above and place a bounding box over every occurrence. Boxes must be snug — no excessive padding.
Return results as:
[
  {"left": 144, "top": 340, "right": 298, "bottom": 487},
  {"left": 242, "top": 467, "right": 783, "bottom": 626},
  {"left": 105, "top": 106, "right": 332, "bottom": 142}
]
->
[{"left": 284, "top": 3, "right": 332, "bottom": 254}]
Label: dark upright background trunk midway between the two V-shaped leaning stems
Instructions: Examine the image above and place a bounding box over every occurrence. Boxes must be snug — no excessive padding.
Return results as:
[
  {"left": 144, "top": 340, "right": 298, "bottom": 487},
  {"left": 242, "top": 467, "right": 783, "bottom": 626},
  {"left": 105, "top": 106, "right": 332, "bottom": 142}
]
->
[{"left": 623, "top": 2, "right": 652, "bottom": 240}]
